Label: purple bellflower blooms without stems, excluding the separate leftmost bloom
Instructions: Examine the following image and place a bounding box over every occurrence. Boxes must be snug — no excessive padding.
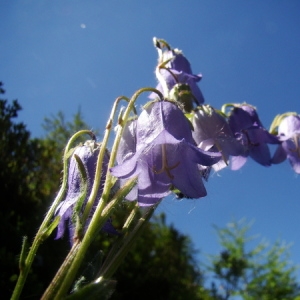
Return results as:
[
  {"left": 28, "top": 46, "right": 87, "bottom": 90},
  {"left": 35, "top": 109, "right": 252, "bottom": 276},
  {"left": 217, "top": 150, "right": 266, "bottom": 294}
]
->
[{"left": 111, "top": 38, "right": 300, "bottom": 206}]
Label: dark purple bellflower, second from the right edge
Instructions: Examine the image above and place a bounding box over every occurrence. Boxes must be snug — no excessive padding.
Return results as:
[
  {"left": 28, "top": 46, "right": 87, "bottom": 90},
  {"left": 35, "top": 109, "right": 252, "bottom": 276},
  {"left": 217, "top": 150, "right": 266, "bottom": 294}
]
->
[{"left": 228, "top": 104, "right": 279, "bottom": 170}]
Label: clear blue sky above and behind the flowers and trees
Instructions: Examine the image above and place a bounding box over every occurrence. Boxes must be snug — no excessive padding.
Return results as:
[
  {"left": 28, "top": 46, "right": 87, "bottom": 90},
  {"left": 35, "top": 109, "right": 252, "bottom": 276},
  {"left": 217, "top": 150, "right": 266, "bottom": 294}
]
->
[{"left": 0, "top": 0, "right": 300, "bottom": 278}]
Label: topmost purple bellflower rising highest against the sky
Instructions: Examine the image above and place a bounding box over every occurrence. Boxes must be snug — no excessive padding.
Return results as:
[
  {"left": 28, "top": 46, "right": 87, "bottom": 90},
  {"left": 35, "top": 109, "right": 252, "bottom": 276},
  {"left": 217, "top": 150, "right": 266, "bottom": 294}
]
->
[{"left": 150, "top": 38, "right": 204, "bottom": 106}]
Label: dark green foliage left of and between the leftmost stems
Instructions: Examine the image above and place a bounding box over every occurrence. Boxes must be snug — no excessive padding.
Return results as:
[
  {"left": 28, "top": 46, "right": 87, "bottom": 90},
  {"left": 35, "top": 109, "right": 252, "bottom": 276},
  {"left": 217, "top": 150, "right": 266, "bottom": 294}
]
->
[{"left": 0, "top": 83, "right": 94, "bottom": 299}]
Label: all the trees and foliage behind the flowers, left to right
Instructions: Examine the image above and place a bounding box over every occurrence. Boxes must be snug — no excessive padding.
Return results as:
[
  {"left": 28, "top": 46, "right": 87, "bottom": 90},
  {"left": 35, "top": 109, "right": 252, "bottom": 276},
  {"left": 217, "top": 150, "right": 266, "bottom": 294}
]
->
[{"left": 0, "top": 83, "right": 300, "bottom": 299}]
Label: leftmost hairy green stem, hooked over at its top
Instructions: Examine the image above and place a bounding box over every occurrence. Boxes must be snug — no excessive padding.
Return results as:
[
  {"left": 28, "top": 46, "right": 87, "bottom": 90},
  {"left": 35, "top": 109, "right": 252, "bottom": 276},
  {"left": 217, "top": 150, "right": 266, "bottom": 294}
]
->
[{"left": 11, "top": 130, "right": 94, "bottom": 300}]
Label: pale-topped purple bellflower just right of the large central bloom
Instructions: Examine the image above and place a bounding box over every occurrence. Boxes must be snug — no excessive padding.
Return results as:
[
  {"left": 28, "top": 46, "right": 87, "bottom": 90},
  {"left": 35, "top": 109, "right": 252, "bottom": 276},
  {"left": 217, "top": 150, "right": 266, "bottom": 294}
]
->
[{"left": 191, "top": 105, "right": 245, "bottom": 170}]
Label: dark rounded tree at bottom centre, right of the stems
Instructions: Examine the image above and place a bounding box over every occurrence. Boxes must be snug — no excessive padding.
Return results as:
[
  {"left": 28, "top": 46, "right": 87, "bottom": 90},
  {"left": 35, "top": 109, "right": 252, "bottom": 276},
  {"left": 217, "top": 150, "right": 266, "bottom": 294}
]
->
[{"left": 112, "top": 215, "right": 209, "bottom": 300}]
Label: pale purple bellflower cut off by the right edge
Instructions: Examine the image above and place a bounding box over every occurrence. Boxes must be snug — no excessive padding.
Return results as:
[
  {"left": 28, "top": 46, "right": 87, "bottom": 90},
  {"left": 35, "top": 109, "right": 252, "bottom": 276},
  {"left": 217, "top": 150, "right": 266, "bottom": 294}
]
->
[{"left": 272, "top": 115, "right": 300, "bottom": 174}]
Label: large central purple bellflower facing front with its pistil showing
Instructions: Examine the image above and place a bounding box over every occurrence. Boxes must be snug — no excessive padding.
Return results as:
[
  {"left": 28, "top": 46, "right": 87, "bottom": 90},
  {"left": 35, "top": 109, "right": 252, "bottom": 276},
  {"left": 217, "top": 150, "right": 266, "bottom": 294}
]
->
[{"left": 111, "top": 101, "right": 220, "bottom": 206}]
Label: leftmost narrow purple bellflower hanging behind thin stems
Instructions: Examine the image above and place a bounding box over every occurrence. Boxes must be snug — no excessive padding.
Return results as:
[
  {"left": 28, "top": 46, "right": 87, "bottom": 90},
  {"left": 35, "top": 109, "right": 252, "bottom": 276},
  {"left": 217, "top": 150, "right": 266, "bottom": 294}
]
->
[{"left": 56, "top": 141, "right": 117, "bottom": 244}]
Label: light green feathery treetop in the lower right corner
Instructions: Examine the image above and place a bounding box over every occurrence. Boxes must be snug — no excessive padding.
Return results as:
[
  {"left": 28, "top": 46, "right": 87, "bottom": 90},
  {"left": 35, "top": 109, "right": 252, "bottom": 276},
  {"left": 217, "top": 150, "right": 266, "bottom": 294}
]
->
[{"left": 208, "top": 220, "right": 300, "bottom": 300}]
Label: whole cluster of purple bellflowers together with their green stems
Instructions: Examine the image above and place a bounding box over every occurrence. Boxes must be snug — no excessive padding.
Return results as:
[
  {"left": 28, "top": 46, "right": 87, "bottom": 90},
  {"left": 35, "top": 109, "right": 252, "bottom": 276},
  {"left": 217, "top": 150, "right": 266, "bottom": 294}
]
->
[{"left": 15, "top": 38, "right": 300, "bottom": 299}]
